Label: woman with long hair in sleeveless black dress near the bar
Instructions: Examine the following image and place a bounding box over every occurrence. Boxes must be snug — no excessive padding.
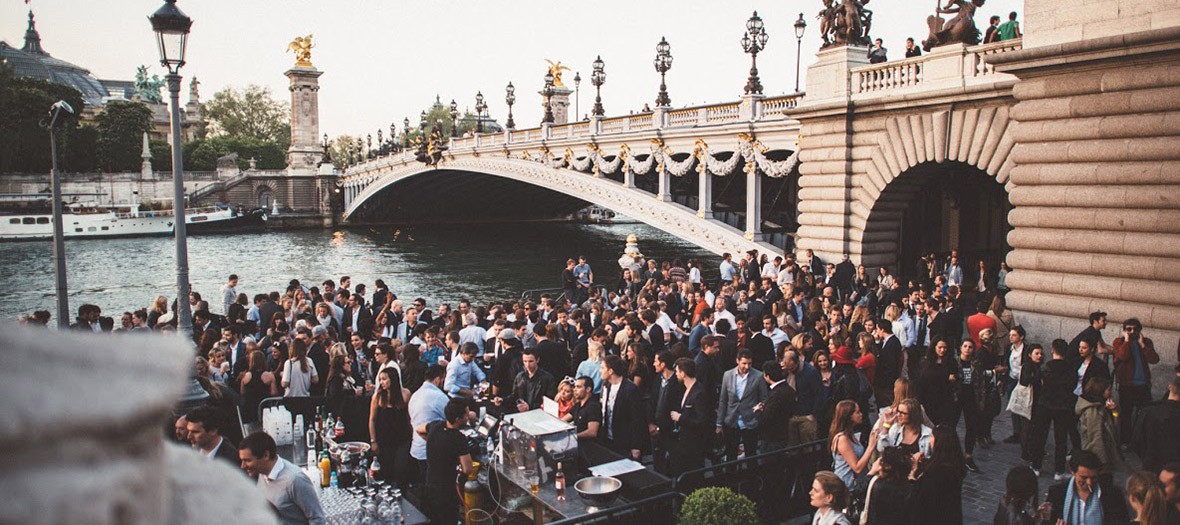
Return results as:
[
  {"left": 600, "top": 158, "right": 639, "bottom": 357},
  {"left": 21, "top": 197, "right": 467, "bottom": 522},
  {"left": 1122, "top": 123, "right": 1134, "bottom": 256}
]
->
[{"left": 369, "top": 368, "right": 412, "bottom": 487}]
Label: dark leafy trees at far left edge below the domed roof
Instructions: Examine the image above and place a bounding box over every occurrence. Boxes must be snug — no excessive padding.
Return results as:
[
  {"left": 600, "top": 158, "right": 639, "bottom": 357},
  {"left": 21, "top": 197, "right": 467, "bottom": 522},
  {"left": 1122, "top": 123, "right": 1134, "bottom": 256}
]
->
[{"left": 0, "top": 66, "right": 85, "bottom": 173}]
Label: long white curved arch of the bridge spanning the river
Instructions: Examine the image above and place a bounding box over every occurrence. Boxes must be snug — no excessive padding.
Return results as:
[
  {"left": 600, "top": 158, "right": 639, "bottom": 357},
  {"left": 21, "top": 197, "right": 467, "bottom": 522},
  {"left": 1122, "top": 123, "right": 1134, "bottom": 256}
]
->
[{"left": 345, "top": 156, "right": 779, "bottom": 254}]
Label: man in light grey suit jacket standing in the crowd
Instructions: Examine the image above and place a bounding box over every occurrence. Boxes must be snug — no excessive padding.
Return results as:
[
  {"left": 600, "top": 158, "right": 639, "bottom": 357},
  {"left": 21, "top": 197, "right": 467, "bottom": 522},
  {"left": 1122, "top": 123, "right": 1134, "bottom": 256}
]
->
[{"left": 717, "top": 349, "right": 768, "bottom": 461}]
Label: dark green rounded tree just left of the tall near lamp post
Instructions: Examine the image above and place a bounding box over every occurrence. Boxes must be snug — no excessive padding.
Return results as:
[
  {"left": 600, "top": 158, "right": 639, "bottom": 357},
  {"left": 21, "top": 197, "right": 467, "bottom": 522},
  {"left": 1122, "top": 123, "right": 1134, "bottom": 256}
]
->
[{"left": 94, "top": 100, "right": 151, "bottom": 171}]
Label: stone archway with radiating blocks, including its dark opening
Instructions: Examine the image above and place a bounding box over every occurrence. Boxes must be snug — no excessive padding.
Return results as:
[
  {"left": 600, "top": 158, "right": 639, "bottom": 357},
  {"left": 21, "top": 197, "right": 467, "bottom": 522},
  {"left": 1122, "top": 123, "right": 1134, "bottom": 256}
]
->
[{"left": 850, "top": 105, "right": 1015, "bottom": 275}]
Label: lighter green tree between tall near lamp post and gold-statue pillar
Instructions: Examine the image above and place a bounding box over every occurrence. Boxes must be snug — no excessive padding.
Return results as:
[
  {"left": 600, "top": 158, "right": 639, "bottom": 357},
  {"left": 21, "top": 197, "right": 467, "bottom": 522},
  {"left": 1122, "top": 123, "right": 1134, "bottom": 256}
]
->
[{"left": 205, "top": 84, "right": 291, "bottom": 151}]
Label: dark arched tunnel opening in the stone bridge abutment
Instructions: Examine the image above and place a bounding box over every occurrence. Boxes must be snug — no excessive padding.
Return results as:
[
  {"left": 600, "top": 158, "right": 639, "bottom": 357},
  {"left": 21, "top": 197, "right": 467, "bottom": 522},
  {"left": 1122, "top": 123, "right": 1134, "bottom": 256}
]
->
[{"left": 865, "top": 163, "right": 1012, "bottom": 288}]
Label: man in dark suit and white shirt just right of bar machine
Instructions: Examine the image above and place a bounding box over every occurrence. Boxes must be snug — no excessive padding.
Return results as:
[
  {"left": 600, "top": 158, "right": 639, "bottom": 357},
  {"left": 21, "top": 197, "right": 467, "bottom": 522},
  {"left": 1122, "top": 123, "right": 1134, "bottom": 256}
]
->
[{"left": 599, "top": 355, "right": 648, "bottom": 461}]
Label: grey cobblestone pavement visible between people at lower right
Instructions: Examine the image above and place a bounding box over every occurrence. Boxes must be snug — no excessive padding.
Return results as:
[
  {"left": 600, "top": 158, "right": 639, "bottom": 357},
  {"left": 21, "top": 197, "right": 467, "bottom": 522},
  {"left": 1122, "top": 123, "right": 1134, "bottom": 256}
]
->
[{"left": 958, "top": 412, "right": 1139, "bottom": 525}]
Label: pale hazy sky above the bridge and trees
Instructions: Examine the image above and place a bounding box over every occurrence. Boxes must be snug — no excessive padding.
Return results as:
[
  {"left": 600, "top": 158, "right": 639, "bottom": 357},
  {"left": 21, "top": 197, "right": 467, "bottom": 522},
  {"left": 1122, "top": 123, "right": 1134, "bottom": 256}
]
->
[{"left": 0, "top": 0, "right": 1023, "bottom": 137}]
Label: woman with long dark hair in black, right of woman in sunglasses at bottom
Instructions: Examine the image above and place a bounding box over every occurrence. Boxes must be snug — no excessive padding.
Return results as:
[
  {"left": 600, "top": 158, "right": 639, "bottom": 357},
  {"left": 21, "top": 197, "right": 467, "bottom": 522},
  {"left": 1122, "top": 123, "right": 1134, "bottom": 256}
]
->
[{"left": 915, "top": 425, "right": 966, "bottom": 525}]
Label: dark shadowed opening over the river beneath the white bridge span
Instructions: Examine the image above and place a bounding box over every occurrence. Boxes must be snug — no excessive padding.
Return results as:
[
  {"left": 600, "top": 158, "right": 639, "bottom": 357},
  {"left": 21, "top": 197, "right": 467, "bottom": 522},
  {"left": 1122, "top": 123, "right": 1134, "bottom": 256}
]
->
[{"left": 349, "top": 170, "right": 590, "bottom": 224}]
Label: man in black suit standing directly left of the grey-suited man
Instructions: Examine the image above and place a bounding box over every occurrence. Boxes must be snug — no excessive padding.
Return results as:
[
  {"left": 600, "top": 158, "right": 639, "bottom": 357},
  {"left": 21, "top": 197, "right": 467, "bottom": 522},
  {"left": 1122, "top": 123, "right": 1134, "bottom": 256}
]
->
[{"left": 668, "top": 357, "right": 716, "bottom": 477}]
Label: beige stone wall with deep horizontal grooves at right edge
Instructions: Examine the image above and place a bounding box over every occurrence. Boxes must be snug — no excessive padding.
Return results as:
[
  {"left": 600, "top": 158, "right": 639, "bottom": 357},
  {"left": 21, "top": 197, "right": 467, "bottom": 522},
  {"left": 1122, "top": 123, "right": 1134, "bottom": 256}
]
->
[{"left": 996, "top": 26, "right": 1180, "bottom": 365}]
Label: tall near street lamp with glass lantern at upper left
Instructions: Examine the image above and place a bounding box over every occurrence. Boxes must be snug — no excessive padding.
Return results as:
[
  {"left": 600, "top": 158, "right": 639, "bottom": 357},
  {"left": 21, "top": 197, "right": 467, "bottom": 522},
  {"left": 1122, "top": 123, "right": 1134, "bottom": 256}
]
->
[{"left": 148, "top": 0, "right": 192, "bottom": 339}]
